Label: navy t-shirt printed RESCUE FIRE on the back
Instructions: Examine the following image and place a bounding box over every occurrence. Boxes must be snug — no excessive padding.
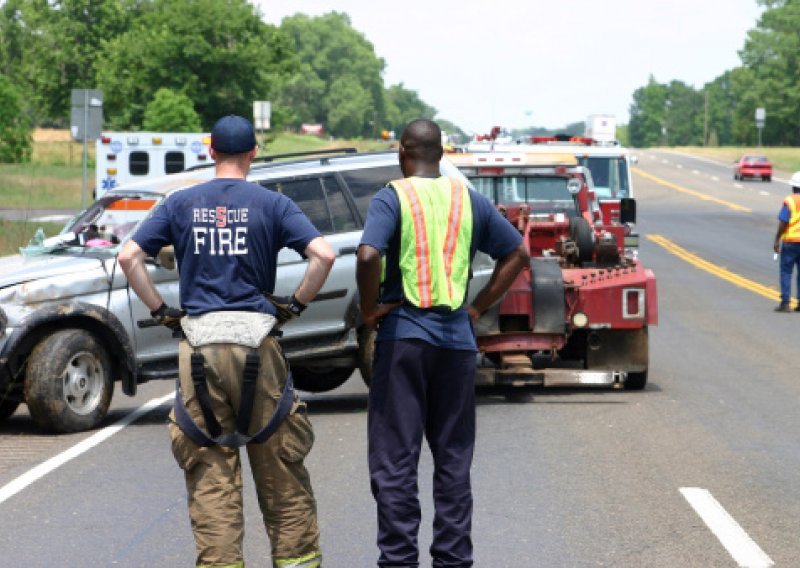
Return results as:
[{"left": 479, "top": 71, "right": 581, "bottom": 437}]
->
[{"left": 132, "top": 178, "right": 320, "bottom": 316}]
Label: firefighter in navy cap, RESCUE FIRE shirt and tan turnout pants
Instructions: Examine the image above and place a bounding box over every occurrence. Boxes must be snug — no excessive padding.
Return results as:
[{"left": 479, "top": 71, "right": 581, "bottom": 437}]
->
[{"left": 120, "top": 116, "right": 334, "bottom": 568}]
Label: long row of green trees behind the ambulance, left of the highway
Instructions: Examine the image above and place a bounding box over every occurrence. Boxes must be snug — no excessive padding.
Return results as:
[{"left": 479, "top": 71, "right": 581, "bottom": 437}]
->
[{"left": 0, "top": 0, "right": 462, "bottom": 161}]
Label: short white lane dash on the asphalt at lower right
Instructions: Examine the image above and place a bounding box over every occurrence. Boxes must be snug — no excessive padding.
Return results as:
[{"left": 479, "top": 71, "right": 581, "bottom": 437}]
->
[{"left": 680, "top": 487, "right": 775, "bottom": 568}]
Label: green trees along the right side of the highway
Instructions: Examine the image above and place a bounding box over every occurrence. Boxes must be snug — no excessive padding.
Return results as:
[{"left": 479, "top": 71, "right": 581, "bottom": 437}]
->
[{"left": 628, "top": 0, "right": 800, "bottom": 147}]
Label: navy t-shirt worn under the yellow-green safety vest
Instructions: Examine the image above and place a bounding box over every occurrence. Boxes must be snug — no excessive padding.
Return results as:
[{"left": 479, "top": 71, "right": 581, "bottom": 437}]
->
[{"left": 361, "top": 181, "right": 522, "bottom": 351}]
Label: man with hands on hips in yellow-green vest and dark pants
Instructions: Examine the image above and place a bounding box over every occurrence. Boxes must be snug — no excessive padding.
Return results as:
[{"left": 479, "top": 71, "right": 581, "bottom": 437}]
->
[{"left": 356, "top": 120, "right": 529, "bottom": 566}]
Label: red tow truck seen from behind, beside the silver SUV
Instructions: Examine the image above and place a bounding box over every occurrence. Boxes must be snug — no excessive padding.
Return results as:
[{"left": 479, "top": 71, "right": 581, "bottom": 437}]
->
[{"left": 448, "top": 151, "right": 658, "bottom": 390}]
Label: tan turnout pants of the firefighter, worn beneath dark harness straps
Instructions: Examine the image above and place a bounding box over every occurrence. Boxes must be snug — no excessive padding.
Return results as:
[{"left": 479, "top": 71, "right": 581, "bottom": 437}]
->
[{"left": 169, "top": 312, "right": 321, "bottom": 568}]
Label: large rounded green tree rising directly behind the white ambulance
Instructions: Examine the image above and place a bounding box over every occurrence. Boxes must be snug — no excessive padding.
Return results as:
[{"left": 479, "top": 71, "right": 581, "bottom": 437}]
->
[{"left": 97, "top": 0, "right": 294, "bottom": 128}]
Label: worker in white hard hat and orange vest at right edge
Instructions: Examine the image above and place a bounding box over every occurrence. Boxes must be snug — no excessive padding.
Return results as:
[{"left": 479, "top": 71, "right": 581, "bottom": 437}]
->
[{"left": 773, "top": 172, "right": 800, "bottom": 312}]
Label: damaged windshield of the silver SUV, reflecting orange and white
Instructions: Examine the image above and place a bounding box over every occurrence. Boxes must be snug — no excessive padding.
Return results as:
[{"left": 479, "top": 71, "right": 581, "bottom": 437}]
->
[{"left": 22, "top": 194, "right": 160, "bottom": 255}]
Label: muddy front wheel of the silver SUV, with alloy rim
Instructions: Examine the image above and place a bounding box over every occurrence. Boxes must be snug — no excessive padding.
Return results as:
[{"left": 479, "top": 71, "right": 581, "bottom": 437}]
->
[{"left": 25, "top": 329, "right": 114, "bottom": 432}]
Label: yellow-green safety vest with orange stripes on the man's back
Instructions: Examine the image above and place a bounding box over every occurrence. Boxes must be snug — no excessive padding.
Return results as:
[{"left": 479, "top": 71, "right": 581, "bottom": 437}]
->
[{"left": 390, "top": 177, "right": 472, "bottom": 310}]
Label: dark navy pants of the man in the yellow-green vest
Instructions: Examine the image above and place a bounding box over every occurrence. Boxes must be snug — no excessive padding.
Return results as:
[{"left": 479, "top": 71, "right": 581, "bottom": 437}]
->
[{"left": 368, "top": 339, "right": 475, "bottom": 567}]
